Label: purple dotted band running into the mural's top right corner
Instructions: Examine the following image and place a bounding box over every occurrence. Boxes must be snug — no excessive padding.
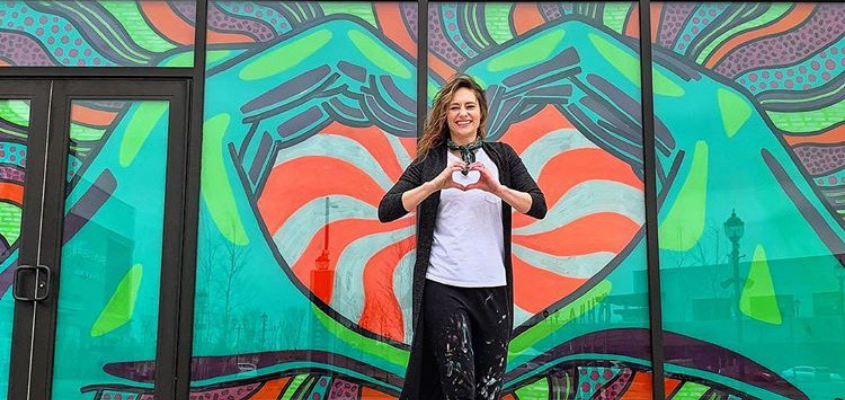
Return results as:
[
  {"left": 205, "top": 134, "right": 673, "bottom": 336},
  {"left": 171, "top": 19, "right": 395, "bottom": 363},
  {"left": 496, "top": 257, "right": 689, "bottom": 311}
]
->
[{"left": 714, "top": 4, "right": 845, "bottom": 79}]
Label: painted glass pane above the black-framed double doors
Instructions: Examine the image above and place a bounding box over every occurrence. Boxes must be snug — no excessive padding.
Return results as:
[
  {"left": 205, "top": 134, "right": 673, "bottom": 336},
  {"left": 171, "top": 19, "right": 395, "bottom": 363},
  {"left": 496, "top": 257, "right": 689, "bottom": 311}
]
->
[{"left": 0, "top": 0, "right": 196, "bottom": 67}]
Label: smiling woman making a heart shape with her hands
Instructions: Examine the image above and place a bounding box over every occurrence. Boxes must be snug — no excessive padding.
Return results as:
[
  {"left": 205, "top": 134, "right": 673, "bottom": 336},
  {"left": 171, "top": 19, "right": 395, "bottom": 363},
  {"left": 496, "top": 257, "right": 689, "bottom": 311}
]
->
[{"left": 379, "top": 75, "right": 546, "bottom": 400}]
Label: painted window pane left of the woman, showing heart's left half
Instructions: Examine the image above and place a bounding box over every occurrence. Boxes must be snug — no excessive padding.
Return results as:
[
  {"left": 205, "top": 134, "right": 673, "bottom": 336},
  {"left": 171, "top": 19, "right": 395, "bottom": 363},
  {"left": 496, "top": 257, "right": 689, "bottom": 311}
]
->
[{"left": 193, "top": 1, "right": 417, "bottom": 399}]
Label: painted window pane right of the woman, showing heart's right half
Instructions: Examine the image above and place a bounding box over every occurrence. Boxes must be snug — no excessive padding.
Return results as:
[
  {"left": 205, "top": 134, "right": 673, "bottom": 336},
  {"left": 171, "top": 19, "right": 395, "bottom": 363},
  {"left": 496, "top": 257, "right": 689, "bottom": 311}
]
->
[{"left": 428, "top": 2, "right": 656, "bottom": 400}]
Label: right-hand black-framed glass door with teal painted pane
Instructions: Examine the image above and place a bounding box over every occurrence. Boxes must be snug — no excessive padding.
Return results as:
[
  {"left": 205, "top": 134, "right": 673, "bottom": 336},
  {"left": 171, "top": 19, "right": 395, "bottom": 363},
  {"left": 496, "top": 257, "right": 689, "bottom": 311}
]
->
[{"left": 0, "top": 80, "right": 187, "bottom": 400}]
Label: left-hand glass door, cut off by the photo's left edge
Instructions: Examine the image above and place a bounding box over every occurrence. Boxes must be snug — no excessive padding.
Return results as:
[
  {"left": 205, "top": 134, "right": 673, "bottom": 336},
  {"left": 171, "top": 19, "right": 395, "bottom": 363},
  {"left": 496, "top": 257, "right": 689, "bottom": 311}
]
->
[{"left": 0, "top": 80, "right": 53, "bottom": 398}]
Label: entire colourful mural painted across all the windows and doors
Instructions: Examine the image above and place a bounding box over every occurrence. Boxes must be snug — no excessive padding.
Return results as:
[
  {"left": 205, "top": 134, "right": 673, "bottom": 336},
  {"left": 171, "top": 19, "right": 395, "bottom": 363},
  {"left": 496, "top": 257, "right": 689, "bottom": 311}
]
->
[{"left": 0, "top": 0, "right": 845, "bottom": 400}]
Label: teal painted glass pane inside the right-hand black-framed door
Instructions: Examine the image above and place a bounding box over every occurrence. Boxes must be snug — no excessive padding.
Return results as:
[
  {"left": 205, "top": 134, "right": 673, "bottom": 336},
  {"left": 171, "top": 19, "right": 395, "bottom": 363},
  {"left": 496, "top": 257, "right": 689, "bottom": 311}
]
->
[{"left": 53, "top": 101, "right": 169, "bottom": 398}]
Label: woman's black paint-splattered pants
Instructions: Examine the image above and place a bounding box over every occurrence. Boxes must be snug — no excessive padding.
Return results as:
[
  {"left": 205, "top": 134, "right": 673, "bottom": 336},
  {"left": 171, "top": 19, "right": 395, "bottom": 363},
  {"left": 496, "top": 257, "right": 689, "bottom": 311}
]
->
[{"left": 423, "top": 280, "right": 511, "bottom": 400}]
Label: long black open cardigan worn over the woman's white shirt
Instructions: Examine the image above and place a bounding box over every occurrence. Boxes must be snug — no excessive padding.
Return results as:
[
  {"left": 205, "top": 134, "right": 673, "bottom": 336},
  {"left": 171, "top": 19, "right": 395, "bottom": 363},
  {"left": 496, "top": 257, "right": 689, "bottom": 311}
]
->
[{"left": 378, "top": 142, "right": 546, "bottom": 400}]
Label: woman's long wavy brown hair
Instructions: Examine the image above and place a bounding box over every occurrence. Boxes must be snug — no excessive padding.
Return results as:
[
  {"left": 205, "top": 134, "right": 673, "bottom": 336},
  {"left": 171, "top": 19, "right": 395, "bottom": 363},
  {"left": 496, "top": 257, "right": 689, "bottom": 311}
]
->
[{"left": 416, "top": 74, "right": 487, "bottom": 161}]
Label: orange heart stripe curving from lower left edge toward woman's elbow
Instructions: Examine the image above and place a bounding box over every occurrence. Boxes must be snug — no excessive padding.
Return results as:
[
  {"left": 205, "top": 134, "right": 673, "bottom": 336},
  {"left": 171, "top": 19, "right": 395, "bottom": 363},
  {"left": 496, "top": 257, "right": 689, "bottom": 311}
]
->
[{"left": 291, "top": 218, "right": 414, "bottom": 304}]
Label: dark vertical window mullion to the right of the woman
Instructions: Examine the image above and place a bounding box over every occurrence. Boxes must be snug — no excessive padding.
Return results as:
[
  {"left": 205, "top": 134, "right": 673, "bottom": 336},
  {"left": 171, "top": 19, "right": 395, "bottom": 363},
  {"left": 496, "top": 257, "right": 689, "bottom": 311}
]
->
[{"left": 639, "top": 0, "right": 666, "bottom": 400}]
